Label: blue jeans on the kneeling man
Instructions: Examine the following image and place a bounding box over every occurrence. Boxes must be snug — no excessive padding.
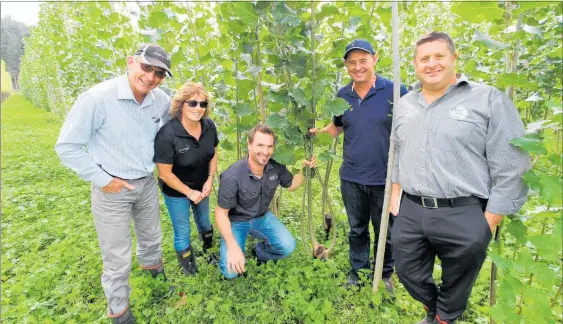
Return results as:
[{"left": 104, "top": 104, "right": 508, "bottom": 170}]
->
[{"left": 219, "top": 211, "right": 295, "bottom": 279}]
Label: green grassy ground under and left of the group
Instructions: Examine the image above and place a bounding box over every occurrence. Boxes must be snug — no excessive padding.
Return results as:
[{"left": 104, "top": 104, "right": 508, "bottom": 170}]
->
[{"left": 1, "top": 94, "right": 490, "bottom": 323}]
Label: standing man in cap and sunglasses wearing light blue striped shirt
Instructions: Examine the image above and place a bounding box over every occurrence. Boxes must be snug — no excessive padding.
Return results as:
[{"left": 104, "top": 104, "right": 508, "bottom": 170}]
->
[{"left": 55, "top": 44, "right": 172, "bottom": 323}]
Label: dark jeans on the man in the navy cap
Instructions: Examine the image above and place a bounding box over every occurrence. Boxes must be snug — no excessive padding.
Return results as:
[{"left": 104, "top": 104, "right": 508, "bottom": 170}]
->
[{"left": 340, "top": 179, "right": 395, "bottom": 279}]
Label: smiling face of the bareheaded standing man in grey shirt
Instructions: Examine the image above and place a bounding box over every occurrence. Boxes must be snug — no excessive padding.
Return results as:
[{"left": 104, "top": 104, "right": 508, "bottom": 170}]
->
[{"left": 414, "top": 40, "right": 457, "bottom": 91}]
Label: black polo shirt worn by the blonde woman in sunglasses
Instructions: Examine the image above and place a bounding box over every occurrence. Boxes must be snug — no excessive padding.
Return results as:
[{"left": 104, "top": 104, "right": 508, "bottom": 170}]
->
[{"left": 153, "top": 118, "right": 219, "bottom": 197}]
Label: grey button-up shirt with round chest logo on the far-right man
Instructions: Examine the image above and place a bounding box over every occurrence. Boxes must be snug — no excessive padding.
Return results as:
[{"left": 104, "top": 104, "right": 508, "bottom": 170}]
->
[{"left": 391, "top": 75, "right": 530, "bottom": 215}]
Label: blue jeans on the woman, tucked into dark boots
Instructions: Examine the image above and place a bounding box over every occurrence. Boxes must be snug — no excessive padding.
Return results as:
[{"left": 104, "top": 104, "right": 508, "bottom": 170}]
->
[{"left": 162, "top": 194, "right": 211, "bottom": 252}]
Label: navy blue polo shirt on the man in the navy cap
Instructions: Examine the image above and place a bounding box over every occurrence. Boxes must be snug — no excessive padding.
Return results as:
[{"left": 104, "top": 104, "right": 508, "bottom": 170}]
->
[{"left": 334, "top": 74, "right": 407, "bottom": 186}]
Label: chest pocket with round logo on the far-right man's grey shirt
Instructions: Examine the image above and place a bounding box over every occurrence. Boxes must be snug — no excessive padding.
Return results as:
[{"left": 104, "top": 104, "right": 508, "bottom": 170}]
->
[{"left": 432, "top": 117, "right": 478, "bottom": 152}]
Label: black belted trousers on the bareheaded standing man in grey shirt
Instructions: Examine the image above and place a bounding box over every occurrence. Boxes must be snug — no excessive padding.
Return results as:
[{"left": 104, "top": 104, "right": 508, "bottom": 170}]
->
[{"left": 391, "top": 196, "right": 492, "bottom": 321}]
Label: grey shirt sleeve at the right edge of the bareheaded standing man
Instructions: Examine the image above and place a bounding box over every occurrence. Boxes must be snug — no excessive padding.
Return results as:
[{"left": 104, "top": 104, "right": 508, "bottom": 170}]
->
[{"left": 486, "top": 89, "right": 531, "bottom": 215}]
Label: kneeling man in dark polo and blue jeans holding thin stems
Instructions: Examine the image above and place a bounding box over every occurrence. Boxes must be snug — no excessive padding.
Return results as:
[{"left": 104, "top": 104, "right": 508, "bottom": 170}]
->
[{"left": 215, "top": 125, "right": 316, "bottom": 279}]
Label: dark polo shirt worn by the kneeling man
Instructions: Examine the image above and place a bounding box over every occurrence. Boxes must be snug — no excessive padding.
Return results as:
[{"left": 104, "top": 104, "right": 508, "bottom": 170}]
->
[{"left": 217, "top": 157, "right": 293, "bottom": 222}]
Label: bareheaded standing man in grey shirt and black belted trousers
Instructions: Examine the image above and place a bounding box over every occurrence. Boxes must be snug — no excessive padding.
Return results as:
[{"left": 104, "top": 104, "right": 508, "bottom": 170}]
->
[{"left": 391, "top": 32, "right": 530, "bottom": 323}]
